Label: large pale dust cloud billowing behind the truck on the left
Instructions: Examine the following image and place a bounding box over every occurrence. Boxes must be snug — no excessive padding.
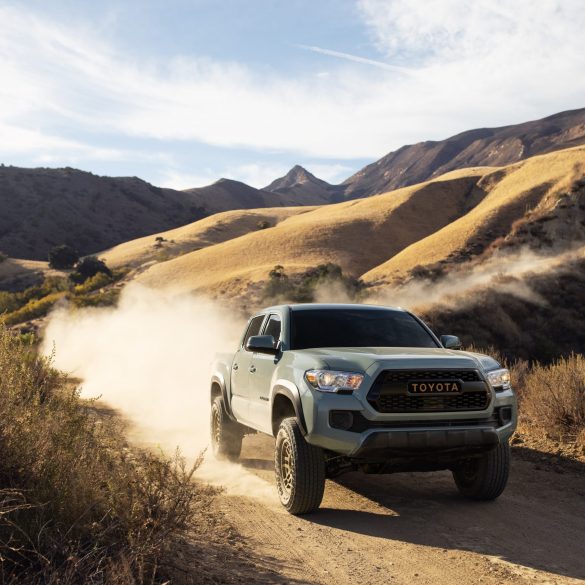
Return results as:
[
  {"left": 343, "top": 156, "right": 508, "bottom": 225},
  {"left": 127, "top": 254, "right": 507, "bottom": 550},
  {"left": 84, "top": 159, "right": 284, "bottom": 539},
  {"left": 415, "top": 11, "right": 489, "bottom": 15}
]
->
[{"left": 43, "top": 284, "right": 273, "bottom": 496}]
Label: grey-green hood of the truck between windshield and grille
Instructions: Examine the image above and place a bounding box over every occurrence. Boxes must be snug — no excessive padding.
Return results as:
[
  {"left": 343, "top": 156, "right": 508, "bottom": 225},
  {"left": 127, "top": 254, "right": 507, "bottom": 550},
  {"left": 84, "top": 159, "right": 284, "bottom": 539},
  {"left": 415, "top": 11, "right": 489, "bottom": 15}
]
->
[{"left": 294, "top": 347, "right": 490, "bottom": 372}]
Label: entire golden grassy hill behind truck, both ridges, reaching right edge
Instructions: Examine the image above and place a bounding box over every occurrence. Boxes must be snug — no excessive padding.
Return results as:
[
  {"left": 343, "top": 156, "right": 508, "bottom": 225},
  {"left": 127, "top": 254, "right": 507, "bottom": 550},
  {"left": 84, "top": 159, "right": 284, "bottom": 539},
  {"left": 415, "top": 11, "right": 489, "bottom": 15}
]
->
[{"left": 132, "top": 147, "right": 585, "bottom": 306}]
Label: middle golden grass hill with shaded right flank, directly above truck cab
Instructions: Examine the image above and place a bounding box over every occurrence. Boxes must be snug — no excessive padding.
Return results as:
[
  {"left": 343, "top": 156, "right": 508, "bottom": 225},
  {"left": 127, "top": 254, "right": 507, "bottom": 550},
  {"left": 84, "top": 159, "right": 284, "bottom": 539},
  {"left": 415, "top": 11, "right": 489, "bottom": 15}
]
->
[{"left": 138, "top": 168, "right": 491, "bottom": 296}]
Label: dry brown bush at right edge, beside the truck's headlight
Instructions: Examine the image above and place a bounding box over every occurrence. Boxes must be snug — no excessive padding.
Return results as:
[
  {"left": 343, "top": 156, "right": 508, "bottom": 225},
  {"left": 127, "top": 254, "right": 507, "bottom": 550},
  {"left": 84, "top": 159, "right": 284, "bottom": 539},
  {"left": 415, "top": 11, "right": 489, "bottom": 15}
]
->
[{"left": 519, "top": 354, "right": 585, "bottom": 440}]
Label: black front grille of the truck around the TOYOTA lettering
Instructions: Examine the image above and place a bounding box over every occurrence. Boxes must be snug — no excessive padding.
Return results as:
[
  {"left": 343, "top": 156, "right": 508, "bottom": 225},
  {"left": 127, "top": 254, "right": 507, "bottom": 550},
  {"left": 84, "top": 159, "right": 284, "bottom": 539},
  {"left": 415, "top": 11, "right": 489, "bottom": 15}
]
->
[{"left": 368, "top": 370, "right": 491, "bottom": 412}]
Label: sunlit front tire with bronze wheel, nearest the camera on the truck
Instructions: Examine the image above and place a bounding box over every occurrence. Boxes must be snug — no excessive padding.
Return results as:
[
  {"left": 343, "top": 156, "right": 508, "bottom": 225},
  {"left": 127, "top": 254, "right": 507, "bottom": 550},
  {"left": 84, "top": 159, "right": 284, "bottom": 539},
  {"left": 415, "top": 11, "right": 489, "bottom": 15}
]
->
[{"left": 274, "top": 418, "right": 325, "bottom": 514}]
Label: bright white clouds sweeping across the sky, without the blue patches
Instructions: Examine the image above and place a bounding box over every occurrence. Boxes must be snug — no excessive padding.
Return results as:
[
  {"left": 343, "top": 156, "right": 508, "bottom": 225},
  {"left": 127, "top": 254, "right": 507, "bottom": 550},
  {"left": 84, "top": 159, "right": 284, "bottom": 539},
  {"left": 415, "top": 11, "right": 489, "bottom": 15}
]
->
[{"left": 0, "top": 0, "right": 585, "bottom": 168}]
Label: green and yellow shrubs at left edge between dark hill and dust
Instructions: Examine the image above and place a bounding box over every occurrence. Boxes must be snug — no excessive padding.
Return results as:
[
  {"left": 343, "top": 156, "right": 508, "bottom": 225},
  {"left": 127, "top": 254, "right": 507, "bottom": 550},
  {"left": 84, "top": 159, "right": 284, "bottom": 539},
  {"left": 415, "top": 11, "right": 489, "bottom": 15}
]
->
[{"left": 0, "top": 256, "right": 125, "bottom": 326}]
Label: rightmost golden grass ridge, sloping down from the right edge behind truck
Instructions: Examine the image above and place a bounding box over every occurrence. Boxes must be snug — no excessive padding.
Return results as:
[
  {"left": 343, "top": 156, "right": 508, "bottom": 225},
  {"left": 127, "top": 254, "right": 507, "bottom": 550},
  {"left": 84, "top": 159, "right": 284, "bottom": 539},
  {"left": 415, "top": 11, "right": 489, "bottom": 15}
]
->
[{"left": 362, "top": 146, "right": 585, "bottom": 285}]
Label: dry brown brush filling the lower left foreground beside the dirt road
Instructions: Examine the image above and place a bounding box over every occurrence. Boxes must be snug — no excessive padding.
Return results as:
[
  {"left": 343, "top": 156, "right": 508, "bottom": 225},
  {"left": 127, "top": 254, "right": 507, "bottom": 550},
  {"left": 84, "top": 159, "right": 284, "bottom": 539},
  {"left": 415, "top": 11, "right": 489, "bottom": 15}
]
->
[{"left": 0, "top": 326, "right": 212, "bottom": 585}]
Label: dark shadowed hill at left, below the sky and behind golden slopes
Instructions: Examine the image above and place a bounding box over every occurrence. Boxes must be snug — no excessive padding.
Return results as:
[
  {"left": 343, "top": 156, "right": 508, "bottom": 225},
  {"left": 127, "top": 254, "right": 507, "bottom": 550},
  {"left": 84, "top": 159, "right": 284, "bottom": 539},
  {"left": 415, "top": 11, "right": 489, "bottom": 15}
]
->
[{"left": 0, "top": 166, "right": 321, "bottom": 260}]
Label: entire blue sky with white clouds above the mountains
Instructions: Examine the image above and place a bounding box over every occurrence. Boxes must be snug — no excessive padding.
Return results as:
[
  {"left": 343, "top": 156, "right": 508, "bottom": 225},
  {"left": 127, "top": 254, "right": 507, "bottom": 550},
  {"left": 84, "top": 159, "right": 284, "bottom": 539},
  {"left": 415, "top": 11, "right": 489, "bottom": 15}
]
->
[{"left": 0, "top": 0, "right": 585, "bottom": 189}]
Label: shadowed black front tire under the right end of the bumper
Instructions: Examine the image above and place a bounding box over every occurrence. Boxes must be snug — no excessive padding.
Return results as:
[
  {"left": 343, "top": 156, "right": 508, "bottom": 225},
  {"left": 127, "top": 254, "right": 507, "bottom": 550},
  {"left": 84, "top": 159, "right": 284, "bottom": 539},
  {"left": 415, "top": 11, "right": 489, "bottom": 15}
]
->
[{"left": 453, "top": 441, "right": 510, "bottom": 501}]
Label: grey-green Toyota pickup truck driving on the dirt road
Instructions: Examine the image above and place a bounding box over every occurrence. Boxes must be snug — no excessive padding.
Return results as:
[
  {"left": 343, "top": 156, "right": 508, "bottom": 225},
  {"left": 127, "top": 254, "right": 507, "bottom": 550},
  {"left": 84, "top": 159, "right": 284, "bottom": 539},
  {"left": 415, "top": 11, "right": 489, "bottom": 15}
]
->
[{"left": 210, "top": 304, "right": 517, "bottom": 514}]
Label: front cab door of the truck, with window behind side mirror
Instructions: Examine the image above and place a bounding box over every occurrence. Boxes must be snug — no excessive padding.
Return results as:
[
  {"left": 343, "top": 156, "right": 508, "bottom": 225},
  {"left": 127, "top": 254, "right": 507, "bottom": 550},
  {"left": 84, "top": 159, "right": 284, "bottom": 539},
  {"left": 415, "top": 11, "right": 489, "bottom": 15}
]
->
[{"left": 249, "top": 313, "right": 282, "bottom": 434}]
